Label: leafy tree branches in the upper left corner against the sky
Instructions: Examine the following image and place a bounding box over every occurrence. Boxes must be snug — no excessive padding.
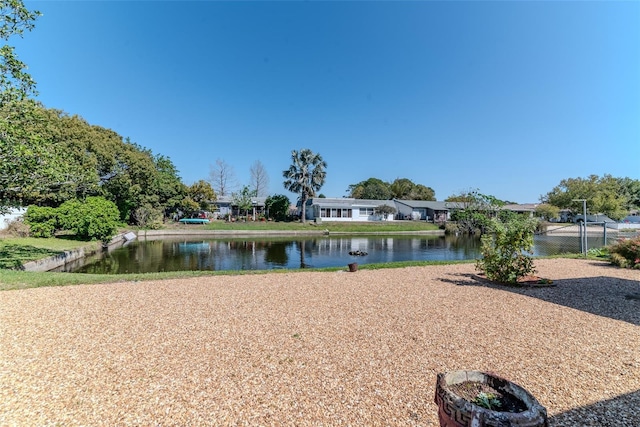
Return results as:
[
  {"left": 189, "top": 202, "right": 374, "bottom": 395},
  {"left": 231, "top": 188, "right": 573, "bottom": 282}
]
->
[{"left": 0, "top": 0, "right": 40, "bottom": 103}]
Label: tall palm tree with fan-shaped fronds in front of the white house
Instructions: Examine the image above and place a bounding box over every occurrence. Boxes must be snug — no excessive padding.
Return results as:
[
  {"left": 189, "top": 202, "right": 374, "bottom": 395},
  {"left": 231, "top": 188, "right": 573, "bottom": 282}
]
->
[{"left": 282, "top": 148, "right": 327, "bottom": 222}]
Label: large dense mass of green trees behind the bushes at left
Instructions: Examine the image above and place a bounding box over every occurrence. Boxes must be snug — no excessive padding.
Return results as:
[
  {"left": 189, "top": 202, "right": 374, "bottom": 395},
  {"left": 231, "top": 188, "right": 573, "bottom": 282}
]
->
[{"left": 0, "top": 100, "right": 186, "bottom": 224}]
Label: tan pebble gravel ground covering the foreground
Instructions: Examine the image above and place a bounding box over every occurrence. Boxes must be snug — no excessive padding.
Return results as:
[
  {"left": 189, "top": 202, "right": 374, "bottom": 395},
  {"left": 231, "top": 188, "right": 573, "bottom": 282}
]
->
[{"left": 0, "top": 259, "right": 640, "bottom": 427}]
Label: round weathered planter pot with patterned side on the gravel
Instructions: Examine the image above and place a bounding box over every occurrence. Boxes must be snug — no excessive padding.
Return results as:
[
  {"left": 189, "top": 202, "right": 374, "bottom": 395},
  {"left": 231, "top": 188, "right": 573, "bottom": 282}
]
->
[{"left": 435, "top": 371, "right": 549, "bottom": 427}]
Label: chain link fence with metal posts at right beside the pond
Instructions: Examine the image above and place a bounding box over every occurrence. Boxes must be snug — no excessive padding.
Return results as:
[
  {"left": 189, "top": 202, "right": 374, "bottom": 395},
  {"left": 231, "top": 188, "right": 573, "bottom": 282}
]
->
[{"left": 534, "top": 222, "right": 640, "bottom": 255}]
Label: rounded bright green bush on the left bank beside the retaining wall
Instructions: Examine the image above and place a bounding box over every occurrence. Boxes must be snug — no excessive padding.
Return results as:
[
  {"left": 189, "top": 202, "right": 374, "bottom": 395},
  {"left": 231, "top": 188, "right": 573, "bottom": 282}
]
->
[{"left": 58, "top": 197, "right": 120, "bottom": 242}]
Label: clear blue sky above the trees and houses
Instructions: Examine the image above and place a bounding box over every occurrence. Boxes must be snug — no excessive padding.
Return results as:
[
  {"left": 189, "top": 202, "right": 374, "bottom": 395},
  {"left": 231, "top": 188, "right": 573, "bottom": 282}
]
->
[{"left": 11, "top": 1, "right": 640, "bottom": 203}]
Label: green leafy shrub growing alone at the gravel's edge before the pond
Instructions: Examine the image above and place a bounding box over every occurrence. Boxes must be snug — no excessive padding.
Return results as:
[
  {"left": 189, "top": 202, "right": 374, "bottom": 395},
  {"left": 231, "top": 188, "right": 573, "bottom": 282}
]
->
[{"left": 476, "top": 217, "right": 538, "bottom": 283}]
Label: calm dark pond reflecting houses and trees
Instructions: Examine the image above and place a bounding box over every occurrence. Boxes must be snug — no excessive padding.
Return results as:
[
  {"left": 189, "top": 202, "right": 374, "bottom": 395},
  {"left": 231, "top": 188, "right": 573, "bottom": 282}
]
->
[{"left": 56, "top": 235, "right": 596, "bottom": 274}]
